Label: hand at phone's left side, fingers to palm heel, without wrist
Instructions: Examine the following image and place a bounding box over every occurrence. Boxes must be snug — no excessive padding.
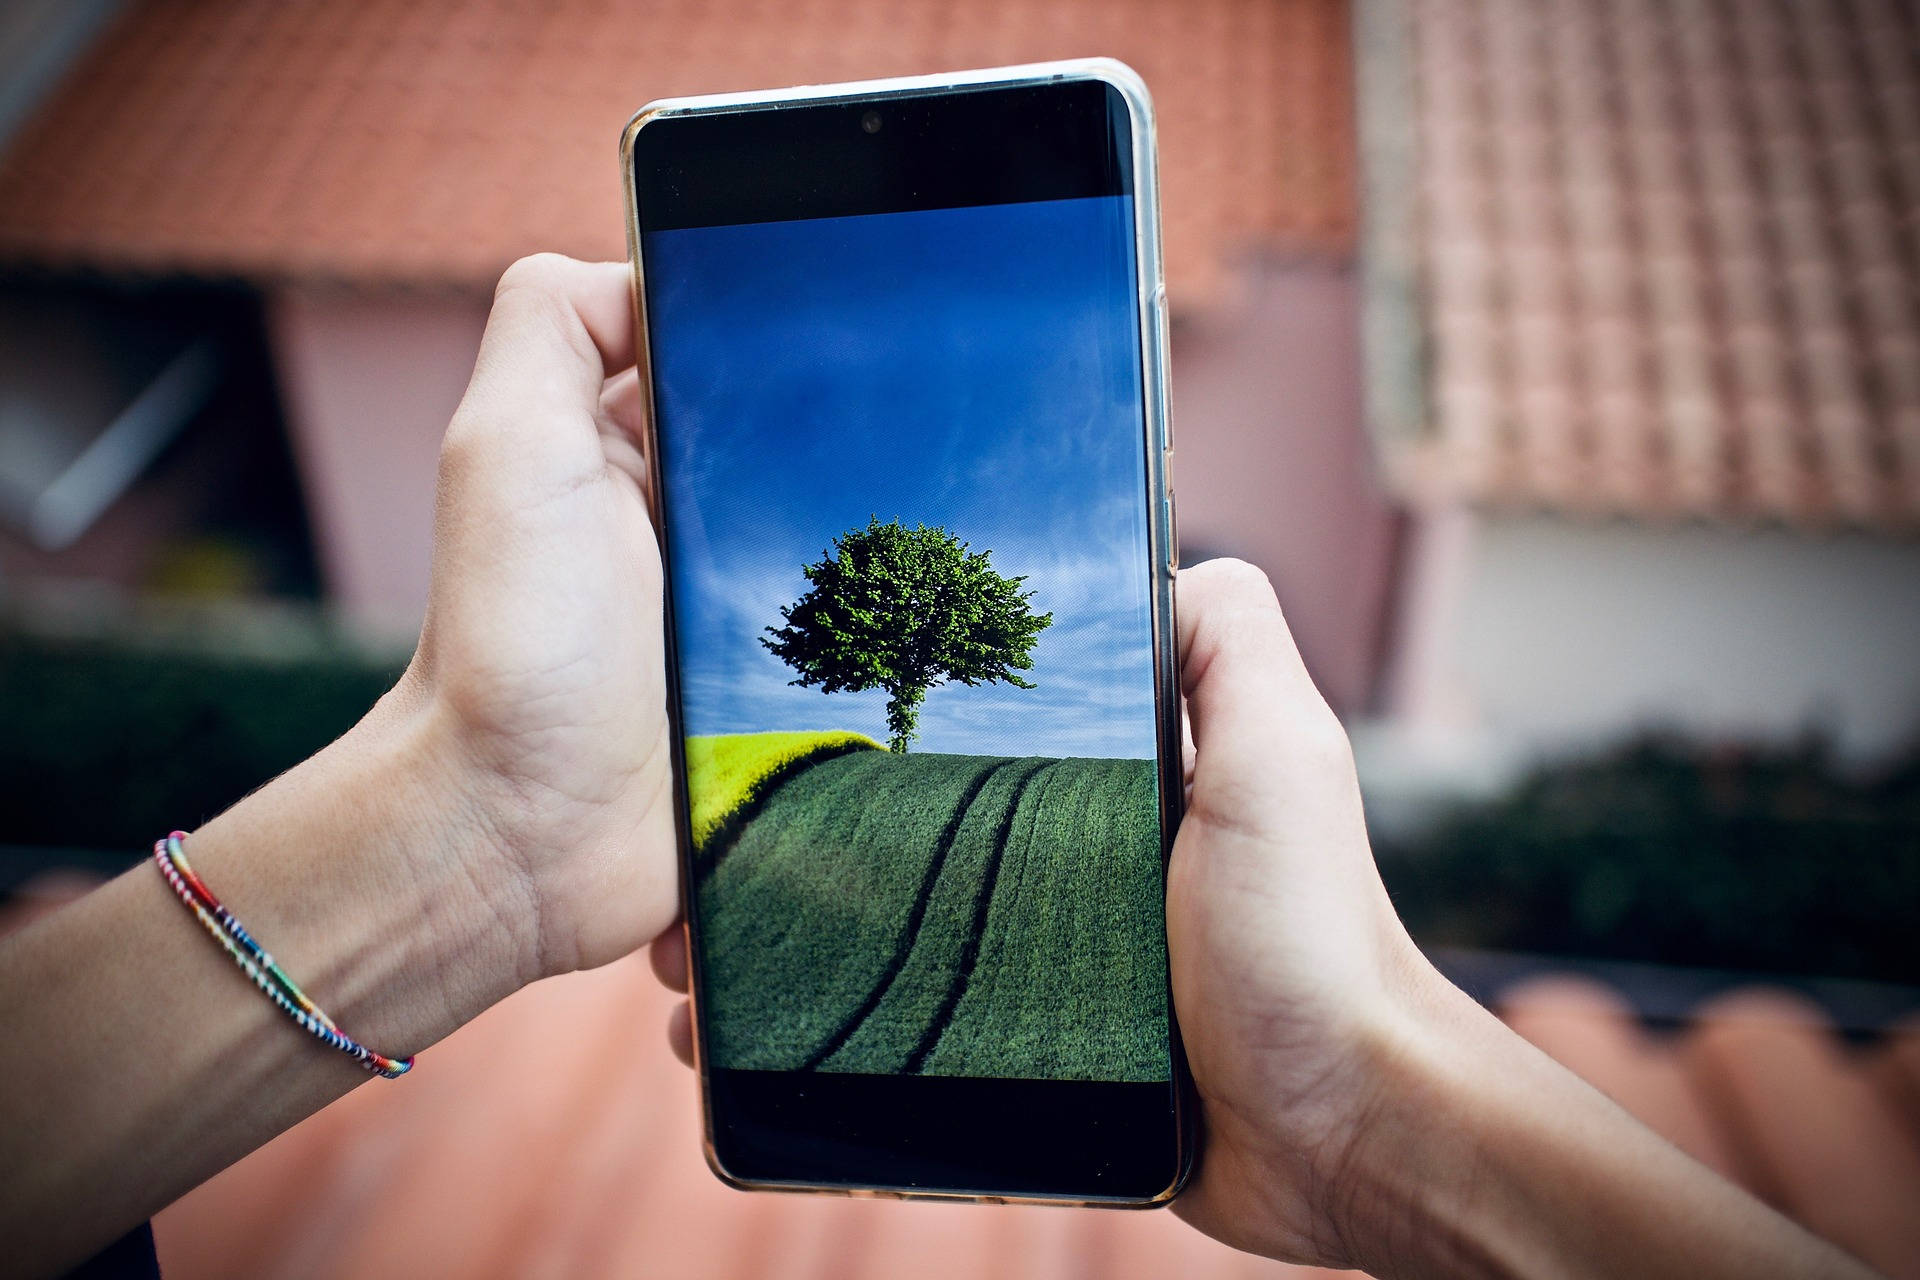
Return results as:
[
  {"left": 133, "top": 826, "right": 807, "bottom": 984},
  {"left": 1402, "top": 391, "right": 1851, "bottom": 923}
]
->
[{"left": 390, "top": 253, "right": 680, "bottom": 983}]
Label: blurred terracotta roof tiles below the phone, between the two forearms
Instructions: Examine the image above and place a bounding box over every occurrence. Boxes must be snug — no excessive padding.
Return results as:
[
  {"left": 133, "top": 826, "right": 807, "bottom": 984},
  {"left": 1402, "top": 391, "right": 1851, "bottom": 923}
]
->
[{"left": 156, "top": 956, "right": 1327, "bottom": 1280}]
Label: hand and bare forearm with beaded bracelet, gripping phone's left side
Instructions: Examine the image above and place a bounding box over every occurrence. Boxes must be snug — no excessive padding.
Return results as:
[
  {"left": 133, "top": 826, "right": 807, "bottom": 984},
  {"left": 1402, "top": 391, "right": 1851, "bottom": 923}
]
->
[{"left": 0, "top": 257, "right": 678, "bottom": 1274}]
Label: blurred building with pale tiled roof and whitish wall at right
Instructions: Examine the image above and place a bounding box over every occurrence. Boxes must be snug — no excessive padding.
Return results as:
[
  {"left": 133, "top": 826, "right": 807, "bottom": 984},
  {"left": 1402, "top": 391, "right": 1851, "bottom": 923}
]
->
[{"left": 1359, "top": 0, "right": 1920, "bottom": 782}]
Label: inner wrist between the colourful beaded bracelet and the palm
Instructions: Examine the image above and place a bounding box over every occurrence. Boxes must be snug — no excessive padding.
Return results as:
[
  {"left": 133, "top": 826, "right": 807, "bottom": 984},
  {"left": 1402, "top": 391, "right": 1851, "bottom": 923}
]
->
[{"left": 188, "top": 679, "right": 538, "bottom": 1057}]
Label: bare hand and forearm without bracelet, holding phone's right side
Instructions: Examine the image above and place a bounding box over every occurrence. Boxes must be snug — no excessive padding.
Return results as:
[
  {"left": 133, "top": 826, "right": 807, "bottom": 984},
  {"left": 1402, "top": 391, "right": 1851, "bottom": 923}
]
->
[{"left": 1167, "top": 560, "right": 1864, "bottom": 1276}]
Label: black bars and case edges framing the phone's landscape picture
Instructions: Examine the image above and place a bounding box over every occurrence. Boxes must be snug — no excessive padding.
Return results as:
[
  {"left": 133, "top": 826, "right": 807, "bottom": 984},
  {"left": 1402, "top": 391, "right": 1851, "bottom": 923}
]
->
[{"left": 622, "top": 63, "right": 1198, "bottom": 1207}]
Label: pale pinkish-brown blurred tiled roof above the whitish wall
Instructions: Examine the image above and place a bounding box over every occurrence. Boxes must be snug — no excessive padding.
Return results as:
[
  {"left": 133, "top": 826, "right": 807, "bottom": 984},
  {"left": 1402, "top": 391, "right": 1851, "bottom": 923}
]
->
[{"left": 1361, "top": 0, "right": 1920, "bottom": 530}]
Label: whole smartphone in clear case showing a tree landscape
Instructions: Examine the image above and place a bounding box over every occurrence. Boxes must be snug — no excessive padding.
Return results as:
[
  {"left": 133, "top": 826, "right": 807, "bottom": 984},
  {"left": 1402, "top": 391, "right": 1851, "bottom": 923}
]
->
[{"left": 622, "top": 59, "right": 1192, "bottom": 1205}]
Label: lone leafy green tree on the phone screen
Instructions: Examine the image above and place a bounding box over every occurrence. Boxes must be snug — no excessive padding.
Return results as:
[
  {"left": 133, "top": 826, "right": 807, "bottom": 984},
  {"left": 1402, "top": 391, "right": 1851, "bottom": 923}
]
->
[{"left": 760, "top": 516, "right": 1054, "bottom": 750}]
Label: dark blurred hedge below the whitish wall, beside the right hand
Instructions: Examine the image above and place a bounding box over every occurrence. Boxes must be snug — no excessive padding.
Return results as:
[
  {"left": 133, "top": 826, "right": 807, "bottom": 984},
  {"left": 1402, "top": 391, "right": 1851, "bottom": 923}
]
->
[{"left": 1379, "top": 739, "right": 1920, "bottom": 983}]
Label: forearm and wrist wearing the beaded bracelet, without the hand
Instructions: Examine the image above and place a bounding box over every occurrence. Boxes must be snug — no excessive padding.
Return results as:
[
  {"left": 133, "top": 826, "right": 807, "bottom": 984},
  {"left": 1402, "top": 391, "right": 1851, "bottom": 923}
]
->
[{"left": 0, "top": 675, "right": 532, "bottom": 1274}]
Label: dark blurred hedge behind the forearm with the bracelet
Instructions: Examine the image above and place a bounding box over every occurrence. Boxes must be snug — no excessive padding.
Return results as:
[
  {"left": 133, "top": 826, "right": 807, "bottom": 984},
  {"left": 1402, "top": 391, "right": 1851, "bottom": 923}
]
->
[{"left": 0, "top": 631, "right": 401, "bottom": 860}]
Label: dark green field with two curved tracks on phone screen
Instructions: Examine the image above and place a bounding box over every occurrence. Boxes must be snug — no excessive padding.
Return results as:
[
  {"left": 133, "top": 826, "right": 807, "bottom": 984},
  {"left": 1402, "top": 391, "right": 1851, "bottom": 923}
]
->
[{"left": 689, "top": 735, "right": 1169, "bottom": 1080}]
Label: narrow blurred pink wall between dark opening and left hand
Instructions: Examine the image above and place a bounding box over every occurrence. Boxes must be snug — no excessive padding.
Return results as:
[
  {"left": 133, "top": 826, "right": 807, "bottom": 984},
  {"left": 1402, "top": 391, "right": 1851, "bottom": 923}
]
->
[{"left": 269, "top": 290, "right": 486, "bottom": 629}]
